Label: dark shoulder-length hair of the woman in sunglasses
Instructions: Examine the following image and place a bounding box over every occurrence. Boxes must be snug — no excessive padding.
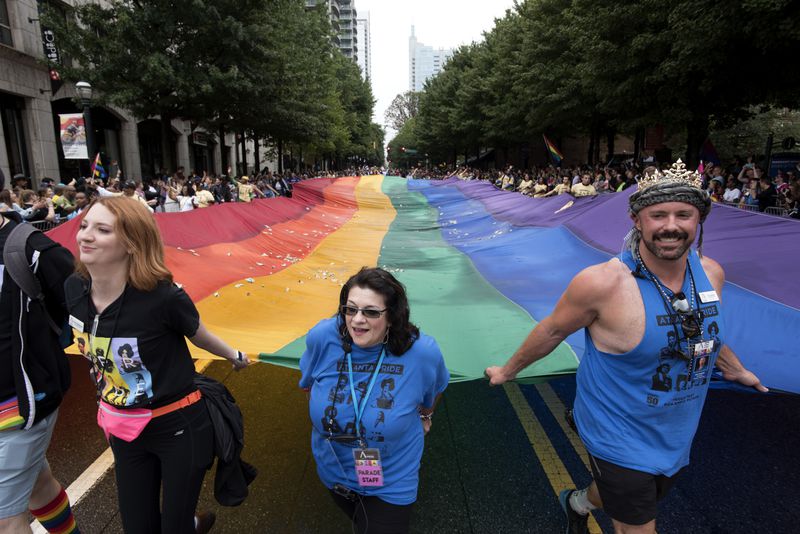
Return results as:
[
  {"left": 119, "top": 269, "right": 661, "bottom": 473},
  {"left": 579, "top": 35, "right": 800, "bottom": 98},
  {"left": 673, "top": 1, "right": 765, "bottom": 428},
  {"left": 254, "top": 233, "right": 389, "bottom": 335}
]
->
[{"left": 337, "top": 267, "right": 419, "bottom": 356}]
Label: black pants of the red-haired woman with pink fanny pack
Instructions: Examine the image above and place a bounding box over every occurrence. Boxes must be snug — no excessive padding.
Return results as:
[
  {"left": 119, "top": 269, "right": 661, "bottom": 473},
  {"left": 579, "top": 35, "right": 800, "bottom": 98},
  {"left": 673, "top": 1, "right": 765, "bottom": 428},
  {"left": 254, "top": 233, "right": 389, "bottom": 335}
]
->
[{"left": 111, "top": 399, "right": 214, "bottom": 534}]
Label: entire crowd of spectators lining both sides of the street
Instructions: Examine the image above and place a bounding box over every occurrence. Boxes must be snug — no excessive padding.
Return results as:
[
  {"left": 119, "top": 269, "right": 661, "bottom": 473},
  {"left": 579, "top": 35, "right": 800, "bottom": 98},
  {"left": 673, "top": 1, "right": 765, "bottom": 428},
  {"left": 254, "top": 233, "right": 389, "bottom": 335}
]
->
[{"left": 0, "top": 161, "right": 800, "bottom": 224}]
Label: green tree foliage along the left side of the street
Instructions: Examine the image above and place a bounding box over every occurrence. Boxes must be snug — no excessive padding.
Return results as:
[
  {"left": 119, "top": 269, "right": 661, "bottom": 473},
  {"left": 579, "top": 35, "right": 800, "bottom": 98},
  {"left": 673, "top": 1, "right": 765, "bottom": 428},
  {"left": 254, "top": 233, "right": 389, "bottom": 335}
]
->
[{"left": 44, "top": 0, "right": 382, "bottom": 166}]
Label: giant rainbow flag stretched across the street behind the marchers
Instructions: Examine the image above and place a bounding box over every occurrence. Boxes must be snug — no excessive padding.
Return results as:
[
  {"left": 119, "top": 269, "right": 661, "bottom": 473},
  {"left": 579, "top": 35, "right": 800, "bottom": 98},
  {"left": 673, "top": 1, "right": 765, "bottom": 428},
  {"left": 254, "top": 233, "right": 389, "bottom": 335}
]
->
[{"left": 49, "top": 176, "right": 800, "bottom": 392}]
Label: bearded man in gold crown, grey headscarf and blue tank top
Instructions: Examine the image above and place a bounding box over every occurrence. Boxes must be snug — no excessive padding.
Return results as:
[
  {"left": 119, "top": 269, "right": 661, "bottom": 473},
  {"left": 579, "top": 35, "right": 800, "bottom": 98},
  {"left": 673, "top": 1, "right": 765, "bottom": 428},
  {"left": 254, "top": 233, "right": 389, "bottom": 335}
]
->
[{"left": 486, "top": 160, "right": 767, "bottom": 534}]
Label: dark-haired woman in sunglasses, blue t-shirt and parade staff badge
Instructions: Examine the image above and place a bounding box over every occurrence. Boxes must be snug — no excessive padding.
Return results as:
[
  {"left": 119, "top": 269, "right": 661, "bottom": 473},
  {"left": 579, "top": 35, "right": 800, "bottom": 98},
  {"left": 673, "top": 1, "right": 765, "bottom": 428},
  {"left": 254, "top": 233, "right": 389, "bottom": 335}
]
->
[{"left": 300, "top": 267, "right": 450, "bottom": 534}]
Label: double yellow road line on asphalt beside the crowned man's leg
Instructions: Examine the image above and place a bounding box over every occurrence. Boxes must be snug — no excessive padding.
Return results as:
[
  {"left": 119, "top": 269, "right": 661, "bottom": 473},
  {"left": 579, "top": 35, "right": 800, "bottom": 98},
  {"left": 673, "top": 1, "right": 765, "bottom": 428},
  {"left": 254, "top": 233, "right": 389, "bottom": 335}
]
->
[{"left": 503, "top": 383, "right": 603, "bottom": 534}]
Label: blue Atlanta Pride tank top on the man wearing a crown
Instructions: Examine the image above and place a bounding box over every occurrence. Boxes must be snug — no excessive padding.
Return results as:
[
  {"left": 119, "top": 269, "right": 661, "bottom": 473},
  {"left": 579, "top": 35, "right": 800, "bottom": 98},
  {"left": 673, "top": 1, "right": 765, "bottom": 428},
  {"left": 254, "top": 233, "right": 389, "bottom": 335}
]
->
[{"left": 574, "top": 251, "right": 725, "bottom": 476}]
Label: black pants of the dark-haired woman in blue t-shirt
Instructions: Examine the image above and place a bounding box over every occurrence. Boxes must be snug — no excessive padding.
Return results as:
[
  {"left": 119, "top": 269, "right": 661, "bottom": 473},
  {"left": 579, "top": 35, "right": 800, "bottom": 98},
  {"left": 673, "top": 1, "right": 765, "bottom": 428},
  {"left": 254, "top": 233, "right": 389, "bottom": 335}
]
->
[{"left": 331, "top": 491, "right": 414, "bottom": 534}]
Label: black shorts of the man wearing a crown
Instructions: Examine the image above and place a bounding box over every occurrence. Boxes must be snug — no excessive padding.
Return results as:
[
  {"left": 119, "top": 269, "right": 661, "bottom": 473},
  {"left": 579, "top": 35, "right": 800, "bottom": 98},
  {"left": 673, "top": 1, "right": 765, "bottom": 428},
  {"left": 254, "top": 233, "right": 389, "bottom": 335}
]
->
[{"left": 589, "top": 455, "right": 683, "bottom": 525}]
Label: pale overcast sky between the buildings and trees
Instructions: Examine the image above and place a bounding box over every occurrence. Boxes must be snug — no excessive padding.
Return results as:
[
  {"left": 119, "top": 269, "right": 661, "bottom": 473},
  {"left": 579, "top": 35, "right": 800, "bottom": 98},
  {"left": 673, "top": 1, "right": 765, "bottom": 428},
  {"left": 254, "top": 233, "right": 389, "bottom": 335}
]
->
[{"left": 354, "top": 0, "right": 514, "bottom": 143}]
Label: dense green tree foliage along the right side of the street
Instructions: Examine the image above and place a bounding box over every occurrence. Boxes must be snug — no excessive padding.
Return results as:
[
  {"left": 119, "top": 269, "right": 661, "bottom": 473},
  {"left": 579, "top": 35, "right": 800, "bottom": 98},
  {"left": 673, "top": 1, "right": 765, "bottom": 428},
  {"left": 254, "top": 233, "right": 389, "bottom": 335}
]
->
[{"left": 417, "top": 0, "right": 800, "bottom": 162}]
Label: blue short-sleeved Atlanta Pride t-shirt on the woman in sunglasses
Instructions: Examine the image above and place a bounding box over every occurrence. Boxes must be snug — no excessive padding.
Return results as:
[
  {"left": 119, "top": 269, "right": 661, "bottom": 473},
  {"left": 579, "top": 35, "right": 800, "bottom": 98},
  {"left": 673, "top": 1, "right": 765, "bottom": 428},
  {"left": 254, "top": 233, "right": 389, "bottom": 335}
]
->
[{"left": 300, "top": 318, "right": 450, "bottom": 505}]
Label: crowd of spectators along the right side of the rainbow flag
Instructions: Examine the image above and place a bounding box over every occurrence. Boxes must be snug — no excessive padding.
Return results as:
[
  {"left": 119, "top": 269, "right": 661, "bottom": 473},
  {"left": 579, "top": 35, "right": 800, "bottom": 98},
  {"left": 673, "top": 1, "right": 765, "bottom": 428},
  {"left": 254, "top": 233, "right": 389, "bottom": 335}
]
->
[{"left": 396, "top": 160, "right": 800, "bottom": 218}]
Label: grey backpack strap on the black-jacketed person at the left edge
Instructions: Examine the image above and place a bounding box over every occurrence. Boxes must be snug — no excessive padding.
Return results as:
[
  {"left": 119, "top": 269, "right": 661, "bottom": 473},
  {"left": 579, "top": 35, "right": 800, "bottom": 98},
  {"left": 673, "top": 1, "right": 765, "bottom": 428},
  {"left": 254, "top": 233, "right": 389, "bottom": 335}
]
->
[{"left": 3, "top": 223, "right": 66, "bottom": 346}]
